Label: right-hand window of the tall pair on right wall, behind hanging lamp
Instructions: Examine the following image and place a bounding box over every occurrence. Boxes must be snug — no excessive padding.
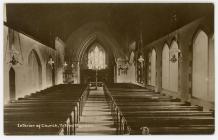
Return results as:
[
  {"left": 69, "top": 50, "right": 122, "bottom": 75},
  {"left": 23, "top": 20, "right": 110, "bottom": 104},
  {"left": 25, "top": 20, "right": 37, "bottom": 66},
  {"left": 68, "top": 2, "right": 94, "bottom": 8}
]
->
[{"left": 169, "top": 40, "right": 179, "bottom": 92}]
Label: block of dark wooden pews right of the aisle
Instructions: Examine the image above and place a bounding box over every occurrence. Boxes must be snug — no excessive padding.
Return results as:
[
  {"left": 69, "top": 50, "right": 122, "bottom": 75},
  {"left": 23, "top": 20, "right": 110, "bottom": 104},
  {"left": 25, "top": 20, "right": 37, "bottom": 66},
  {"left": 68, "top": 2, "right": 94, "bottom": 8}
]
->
[{"left": 104, "top": 83, "right": 214, "bottom": 135}]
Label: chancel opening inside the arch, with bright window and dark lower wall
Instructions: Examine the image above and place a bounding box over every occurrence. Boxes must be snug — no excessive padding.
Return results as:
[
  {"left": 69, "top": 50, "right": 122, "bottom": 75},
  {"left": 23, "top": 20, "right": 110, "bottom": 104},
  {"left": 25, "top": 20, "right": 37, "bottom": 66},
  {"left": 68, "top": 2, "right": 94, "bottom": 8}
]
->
[{"left": 80, "top": 40, "right": 115, "bottom": 83}]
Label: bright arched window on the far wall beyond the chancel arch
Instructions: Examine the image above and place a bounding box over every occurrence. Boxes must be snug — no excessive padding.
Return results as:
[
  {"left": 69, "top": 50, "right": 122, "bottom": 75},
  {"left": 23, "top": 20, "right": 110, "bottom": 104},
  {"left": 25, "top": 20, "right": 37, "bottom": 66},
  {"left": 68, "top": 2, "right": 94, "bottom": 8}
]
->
[{"left": 88, "top": 44, "right": 106, "bottom": 69}]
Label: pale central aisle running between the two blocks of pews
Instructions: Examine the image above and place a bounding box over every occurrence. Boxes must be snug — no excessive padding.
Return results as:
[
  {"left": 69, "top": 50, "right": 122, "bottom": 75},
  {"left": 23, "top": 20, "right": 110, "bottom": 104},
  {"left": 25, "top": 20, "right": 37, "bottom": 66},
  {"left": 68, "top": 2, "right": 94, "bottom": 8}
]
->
[{"left": 76, "top": 87, "right": 116, "bottom": 135}]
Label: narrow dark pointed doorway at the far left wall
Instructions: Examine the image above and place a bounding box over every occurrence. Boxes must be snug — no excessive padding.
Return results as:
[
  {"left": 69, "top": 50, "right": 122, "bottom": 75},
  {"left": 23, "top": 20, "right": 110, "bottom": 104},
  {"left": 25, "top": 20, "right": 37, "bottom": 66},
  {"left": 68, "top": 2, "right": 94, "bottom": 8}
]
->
[{"left": 9, "top": 67, "right": 16, "bottom": 100}]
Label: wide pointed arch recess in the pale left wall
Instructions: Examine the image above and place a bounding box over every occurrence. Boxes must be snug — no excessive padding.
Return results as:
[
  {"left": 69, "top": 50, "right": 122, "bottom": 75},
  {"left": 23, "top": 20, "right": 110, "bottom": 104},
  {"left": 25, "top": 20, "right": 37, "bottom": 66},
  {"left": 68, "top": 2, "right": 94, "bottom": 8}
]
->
[{"left": 28, "top": 50, "right": 42, "bottom": 92}]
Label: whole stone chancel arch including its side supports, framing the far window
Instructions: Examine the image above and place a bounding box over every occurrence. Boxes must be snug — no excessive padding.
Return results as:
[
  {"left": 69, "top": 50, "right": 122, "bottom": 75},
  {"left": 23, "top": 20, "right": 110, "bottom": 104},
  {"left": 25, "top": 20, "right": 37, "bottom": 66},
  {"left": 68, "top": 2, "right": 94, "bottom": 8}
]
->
[{"left": 65, "top": 30, "right": 125, "bottom": 83}]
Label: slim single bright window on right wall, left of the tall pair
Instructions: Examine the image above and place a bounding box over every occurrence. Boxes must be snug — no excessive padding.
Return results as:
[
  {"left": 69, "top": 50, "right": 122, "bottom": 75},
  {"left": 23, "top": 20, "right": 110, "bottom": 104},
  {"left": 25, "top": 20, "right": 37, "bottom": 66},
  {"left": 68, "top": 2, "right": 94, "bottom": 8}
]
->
[{"left": 151, "top": 49, "right": 156, "bottom": 86}]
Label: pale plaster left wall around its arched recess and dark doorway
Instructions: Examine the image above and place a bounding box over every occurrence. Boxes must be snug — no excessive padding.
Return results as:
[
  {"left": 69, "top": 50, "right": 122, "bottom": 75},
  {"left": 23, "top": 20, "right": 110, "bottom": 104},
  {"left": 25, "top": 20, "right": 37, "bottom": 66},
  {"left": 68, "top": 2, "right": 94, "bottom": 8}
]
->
[{"left": 4, "top": 26, "right": 63, "bottom": 103}]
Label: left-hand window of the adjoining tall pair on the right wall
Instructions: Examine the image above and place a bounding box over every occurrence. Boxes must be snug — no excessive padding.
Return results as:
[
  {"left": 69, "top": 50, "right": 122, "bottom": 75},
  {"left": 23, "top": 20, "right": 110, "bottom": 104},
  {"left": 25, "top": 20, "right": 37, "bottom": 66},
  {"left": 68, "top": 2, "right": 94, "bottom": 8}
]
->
[{"left": 162, "top": 44, "right": 170, "bottom": 89}]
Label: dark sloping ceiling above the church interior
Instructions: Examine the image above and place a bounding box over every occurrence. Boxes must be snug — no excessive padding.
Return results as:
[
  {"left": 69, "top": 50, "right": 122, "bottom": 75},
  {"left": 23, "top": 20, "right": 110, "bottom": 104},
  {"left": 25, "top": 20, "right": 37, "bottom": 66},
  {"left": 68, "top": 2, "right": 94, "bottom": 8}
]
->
[{"left": 6, "top": 3, "right": 214, "bottom": 47}]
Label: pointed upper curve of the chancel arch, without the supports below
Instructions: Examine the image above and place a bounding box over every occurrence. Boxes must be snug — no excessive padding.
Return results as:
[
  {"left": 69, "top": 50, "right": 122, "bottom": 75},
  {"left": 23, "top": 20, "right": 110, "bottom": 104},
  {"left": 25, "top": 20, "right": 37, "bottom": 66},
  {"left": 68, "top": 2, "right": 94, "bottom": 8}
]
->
[{"left": 66, "top": 22, "right": 125, "bottom": 62}]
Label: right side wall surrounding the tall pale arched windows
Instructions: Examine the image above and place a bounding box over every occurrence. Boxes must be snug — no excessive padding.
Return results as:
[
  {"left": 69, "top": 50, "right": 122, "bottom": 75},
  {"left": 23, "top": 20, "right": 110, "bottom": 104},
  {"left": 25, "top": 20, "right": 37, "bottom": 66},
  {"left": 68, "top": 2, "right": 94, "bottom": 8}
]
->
[{"left": 144, "top": 17, "right": 215, "bottom": 109}]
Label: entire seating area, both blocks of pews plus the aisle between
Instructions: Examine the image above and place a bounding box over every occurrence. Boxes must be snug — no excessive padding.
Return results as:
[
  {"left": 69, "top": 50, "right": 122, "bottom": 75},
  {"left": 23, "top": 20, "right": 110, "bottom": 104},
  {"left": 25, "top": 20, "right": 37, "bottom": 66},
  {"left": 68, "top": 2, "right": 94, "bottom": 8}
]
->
[{"left": 4, "top": 83, "right": 214, "bottom": 135}]
